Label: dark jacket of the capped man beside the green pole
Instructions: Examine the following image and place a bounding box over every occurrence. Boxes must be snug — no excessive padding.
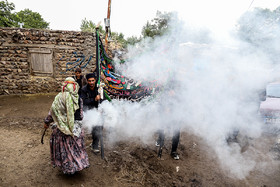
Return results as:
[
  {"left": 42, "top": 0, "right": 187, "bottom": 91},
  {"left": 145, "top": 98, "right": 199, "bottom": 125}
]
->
[{"left": 81, "top": 84, "right": 105, "bottom": 111}]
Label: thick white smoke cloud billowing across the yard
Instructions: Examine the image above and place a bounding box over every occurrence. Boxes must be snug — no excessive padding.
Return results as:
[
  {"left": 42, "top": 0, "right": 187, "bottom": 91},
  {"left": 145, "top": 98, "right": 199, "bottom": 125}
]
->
[{"left": 84, "top": 9, "right": 280, "bottom": 178}]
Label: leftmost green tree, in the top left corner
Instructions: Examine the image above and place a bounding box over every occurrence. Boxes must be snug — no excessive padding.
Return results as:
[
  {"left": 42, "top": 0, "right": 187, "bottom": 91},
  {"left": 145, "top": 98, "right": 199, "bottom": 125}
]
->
[{"left": 0, "top": 0, "right": 17, "bottom": 27}]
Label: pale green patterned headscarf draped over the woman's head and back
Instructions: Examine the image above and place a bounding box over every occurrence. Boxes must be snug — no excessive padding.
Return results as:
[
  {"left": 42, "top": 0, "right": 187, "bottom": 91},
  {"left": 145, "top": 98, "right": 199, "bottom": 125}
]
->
[{"left": 51, "top": 77, "right": 79, "bottom": 136}]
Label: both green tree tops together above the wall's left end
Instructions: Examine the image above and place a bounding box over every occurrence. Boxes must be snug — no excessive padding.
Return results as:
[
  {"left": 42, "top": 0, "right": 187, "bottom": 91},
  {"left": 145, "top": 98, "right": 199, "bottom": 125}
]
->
[{"left": 0, "top": 0, "right": 49, "bottom": 29}]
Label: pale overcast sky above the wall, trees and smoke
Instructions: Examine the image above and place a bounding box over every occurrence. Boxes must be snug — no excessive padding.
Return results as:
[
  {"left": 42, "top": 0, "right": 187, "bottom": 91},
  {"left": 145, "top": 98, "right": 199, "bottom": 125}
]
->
[{"left": 8, "top": 0, "right": 280, "bottom": 37}]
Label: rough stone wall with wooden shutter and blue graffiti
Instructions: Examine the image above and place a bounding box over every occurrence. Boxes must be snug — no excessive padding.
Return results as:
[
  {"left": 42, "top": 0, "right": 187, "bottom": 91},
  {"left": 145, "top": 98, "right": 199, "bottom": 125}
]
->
[{"left": 0, "top": 27, "right": 96, "bottom": 95}]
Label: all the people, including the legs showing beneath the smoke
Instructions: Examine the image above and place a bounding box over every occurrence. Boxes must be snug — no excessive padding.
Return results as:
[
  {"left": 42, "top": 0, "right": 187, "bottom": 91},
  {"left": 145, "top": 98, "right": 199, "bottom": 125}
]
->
[{"left": 44, "top": 68, "right": 180, "bottom": 174}]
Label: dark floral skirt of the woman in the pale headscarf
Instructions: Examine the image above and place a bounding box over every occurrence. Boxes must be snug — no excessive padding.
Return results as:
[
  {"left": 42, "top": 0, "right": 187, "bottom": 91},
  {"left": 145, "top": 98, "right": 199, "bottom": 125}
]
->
[{"left": 50, "top": 126, "right": 90, "bottom": 174}]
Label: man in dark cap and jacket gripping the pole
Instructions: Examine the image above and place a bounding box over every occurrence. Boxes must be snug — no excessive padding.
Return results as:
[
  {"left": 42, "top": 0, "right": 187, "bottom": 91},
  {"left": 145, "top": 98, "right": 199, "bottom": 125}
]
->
[{"left": 81, "top": 73, "right": 104, "bottom": 153}]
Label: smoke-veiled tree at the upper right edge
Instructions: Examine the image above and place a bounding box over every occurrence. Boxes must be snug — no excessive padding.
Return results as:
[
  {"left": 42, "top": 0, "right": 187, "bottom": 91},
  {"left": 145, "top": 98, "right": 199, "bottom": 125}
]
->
[{"left": 237, "top": 7, "right": 280, "bottom": 62}]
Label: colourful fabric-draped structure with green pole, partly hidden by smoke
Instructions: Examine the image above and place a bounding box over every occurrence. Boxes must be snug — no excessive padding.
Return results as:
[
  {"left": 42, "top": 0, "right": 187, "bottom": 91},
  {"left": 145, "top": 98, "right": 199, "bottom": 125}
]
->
[{"left": 96, "top": 29, "right": 160, "bottom": 101}]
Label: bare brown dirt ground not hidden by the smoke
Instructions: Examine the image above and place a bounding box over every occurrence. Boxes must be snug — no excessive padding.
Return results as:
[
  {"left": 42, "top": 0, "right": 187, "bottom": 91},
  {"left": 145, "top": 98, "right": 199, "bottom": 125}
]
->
[{"left": 0, "top": 94, "right": 280, "bottom": 187}]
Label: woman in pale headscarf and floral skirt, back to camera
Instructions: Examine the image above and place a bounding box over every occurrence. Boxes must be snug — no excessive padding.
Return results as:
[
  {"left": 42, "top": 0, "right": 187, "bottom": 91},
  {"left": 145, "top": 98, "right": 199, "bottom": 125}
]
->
[{"left": 44, "top": 77, "right": 90, "bottom": 174}]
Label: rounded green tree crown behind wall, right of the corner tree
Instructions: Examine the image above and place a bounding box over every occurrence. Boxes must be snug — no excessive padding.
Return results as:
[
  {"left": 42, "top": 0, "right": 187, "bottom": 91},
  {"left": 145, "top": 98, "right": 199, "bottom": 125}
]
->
[{"left": 16, "top": 9, "right": 49, "bottom": 29}]
